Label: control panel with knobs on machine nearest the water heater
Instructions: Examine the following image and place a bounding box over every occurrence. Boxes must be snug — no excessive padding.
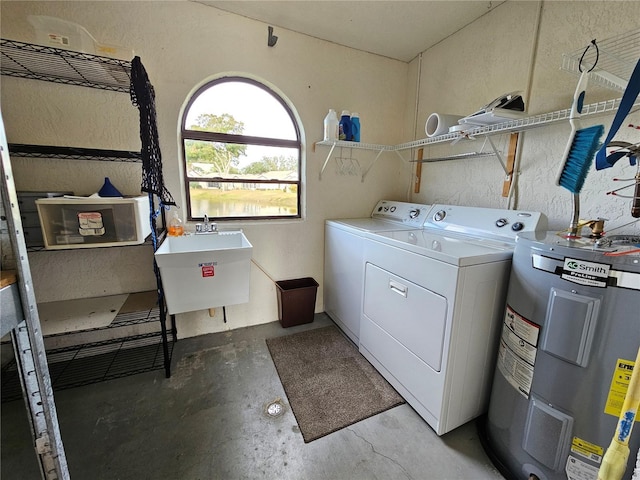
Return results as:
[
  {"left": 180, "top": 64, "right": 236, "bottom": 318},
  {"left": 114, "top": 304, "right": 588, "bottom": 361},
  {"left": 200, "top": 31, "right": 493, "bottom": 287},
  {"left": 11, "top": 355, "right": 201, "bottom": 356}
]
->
[{"left": 425, "top": 205, "right": 547, "bottom": 240}]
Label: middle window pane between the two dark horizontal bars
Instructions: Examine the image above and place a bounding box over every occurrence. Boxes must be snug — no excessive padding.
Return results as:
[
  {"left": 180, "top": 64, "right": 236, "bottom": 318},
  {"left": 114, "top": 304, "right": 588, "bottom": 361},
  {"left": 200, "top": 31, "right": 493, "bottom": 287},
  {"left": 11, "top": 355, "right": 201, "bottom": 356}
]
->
[{"left": 184, "top": 140, "right": 299, "bottom": 181}]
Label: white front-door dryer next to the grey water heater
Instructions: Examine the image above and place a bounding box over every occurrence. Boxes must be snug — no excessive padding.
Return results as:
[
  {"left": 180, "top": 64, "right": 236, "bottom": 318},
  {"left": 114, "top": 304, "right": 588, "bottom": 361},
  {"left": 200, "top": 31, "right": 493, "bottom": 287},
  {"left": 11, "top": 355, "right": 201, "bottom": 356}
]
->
[{"left": 359, "top": 205, "right": 547, "bottom": 435}]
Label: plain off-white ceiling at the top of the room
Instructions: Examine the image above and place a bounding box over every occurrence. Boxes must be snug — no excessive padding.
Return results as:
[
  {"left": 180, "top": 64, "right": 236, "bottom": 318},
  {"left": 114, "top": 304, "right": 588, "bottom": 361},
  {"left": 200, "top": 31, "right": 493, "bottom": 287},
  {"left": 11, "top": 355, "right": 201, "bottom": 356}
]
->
[{"left": 192, "top": 0, "right": 504, "bottom": 62}]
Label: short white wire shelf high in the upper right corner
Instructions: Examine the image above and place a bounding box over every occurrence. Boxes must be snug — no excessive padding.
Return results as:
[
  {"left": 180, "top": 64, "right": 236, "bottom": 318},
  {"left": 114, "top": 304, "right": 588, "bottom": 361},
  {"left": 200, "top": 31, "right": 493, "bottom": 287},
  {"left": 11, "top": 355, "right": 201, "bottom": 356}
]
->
[{"left": 562, "top": 28, "right": 640, "bottom": 91}]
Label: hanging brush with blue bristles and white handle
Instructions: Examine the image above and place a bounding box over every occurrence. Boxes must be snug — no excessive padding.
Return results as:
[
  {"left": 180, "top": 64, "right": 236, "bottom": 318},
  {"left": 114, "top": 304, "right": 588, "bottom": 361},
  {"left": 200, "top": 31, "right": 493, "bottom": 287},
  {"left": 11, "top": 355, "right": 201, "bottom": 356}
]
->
[{"left": 556, "top": 70, "right": 604, "bottom": 238}]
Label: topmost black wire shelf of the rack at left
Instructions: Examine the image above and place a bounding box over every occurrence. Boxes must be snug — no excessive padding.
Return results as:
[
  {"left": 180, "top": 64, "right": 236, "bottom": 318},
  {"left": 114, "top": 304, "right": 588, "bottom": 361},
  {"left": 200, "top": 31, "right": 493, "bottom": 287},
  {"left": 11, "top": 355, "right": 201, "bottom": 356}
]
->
[{"left": 0, "top": 38, "right": 131, "bottom": 93}]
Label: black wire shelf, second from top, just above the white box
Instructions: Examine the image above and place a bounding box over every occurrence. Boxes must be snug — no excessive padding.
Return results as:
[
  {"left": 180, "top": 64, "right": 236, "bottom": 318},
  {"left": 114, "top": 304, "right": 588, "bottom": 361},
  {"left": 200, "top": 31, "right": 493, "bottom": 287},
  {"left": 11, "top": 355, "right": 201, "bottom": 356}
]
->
[{"left": 9, "top": 143, "right": 142, "bottom": 163}]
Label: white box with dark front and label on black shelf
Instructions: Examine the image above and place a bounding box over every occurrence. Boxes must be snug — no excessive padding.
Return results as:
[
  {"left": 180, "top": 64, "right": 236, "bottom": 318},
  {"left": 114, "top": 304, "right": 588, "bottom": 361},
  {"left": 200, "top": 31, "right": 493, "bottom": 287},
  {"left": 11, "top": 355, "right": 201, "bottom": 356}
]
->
[{"left": 36, "top": 195, "right": 151, "bottom": 250}]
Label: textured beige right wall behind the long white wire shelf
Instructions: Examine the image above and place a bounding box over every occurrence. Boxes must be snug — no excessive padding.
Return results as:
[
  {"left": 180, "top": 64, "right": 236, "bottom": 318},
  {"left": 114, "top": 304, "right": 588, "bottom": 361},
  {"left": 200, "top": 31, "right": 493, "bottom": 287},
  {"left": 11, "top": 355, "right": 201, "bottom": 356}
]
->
[{"left": 409, "top": 1, "right": 640, "bottom": 234}]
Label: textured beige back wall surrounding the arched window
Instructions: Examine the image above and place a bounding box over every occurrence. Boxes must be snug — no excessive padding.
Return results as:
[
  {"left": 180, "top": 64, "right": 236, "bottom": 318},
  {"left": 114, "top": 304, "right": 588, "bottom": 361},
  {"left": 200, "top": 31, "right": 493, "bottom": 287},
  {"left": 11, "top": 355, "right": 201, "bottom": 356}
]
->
[{"left": 0, "top": 1, "right": 409, "bottom": 336}]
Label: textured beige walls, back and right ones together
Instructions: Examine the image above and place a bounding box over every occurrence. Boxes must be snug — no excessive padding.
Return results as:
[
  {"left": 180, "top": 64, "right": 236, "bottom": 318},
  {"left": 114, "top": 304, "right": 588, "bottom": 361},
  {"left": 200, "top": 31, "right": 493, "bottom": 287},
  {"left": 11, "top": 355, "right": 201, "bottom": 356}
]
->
[{"left": 0, "top": 1, "right": 640, "bottom": 336}]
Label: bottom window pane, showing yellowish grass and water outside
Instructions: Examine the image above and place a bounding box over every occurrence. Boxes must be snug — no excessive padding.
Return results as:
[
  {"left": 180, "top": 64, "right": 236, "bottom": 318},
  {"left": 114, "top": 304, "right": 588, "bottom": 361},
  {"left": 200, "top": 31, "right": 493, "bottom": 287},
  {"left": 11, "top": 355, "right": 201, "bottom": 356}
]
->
[{"left": 189, "top": 182, "right": 298, "bottom": 218}]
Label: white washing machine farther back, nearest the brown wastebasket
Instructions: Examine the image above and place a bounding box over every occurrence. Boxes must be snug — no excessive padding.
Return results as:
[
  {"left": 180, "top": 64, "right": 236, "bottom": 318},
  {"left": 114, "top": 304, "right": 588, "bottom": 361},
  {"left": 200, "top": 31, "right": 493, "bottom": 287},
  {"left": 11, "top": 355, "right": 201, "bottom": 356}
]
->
[{"left": 324, "top": 200, "right": 430, "bottom": 344}]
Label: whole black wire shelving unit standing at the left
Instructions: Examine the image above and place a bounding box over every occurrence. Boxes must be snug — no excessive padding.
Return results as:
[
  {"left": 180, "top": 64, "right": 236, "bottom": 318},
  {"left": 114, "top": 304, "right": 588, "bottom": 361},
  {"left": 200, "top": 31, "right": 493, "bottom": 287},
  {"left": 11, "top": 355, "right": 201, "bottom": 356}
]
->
[{"left": 0, "top": 39, "right": 177, "bottom": 402}]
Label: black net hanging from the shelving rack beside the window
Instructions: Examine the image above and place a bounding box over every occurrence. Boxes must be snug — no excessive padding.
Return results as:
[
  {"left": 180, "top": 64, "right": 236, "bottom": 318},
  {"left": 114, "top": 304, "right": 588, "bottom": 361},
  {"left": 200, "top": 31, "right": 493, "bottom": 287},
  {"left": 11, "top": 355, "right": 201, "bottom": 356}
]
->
[{"left": 130, "top": 56, "right": 176, "bottom": 205}]
